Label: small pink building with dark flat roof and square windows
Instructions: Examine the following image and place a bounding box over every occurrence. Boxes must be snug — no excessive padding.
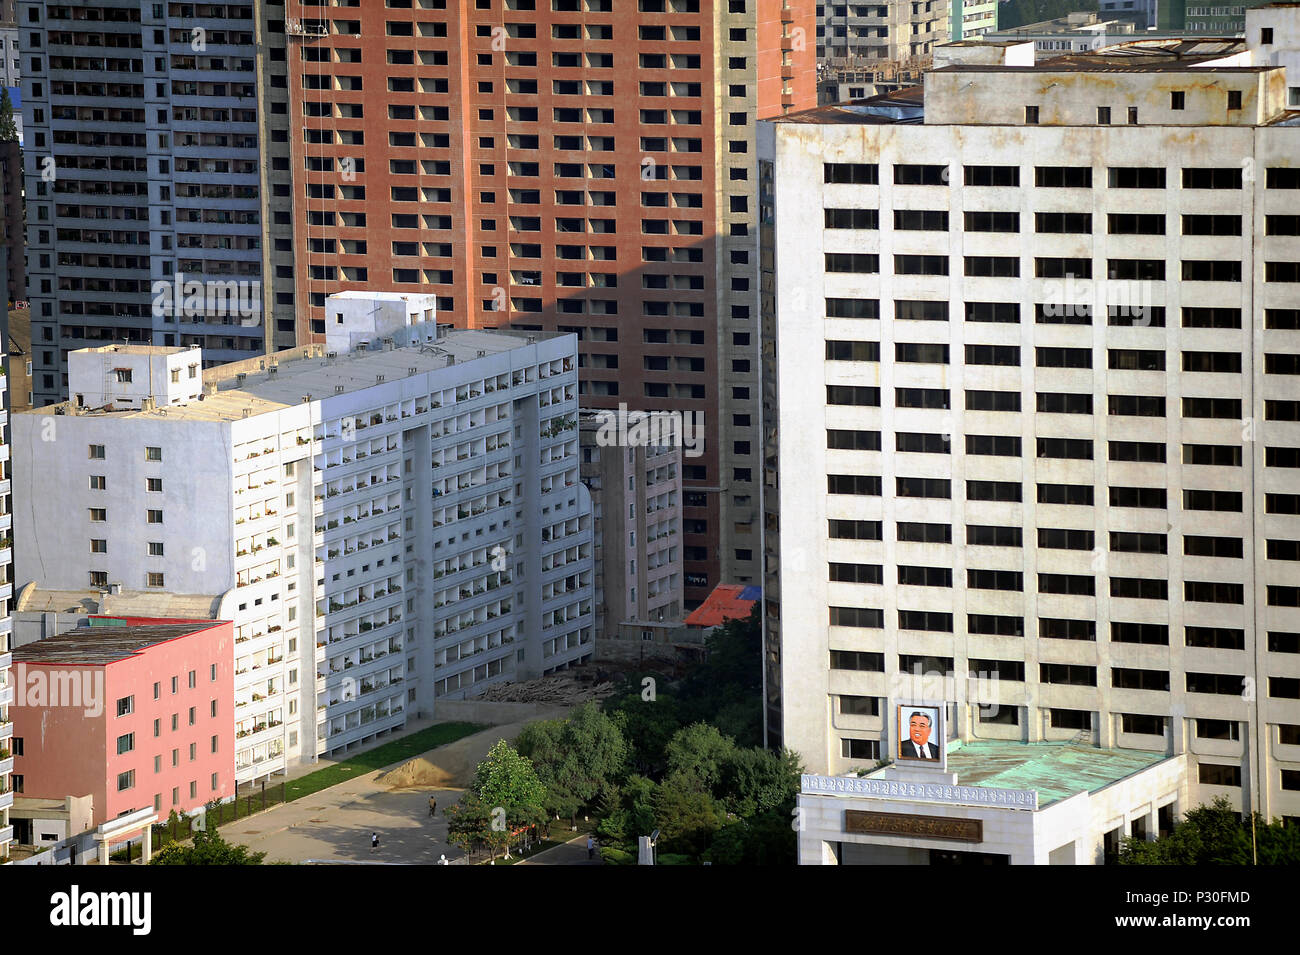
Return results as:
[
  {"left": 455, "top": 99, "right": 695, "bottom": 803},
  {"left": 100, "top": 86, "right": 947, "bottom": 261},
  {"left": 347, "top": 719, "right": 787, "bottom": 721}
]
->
[{"left": 9, "top": 618, "right": 235, "bottom": 825}]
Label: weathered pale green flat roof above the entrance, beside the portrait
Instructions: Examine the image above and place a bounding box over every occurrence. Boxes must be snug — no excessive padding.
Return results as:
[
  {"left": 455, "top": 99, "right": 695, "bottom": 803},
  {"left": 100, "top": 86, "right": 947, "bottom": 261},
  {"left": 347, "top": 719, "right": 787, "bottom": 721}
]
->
[{"left": 948, "top": 741, "right": 1166, "bottom": 808}]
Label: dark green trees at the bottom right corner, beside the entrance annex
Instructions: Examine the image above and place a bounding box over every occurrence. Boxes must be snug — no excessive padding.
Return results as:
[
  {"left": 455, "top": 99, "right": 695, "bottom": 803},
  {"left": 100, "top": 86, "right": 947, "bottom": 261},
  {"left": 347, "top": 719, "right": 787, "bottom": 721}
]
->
[{"left": 1119, "top": 796, "right": 1300, "bottom": 865}]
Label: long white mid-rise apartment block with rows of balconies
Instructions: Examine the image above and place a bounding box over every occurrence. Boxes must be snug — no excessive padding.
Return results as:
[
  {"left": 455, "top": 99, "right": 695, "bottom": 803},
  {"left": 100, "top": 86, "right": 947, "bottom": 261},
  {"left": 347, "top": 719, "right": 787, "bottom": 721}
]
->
[{"left": 14, "top": 294, "right": 593, "bottom": 782}]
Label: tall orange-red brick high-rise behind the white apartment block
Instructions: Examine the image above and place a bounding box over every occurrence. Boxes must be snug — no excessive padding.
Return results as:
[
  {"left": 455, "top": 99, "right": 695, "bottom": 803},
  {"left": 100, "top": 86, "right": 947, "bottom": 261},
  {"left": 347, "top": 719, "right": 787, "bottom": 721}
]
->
[{"left": 285, "top": 0, "right": 816, "bottom": 604}]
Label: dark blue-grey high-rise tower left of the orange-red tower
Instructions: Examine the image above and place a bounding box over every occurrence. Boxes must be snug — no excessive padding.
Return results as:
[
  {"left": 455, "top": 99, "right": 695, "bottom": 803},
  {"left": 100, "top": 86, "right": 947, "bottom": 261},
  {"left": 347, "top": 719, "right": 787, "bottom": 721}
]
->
[{"left": 17, "top": 0, "right": 294, "bottom": 407}]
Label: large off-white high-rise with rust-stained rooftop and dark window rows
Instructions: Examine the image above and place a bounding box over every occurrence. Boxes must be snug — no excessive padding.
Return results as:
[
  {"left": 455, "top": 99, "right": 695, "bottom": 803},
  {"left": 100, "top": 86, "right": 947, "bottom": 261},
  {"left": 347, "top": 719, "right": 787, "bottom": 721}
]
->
[{"left": 761, "top": 16, "right": 1300, "bottom": 816}]
